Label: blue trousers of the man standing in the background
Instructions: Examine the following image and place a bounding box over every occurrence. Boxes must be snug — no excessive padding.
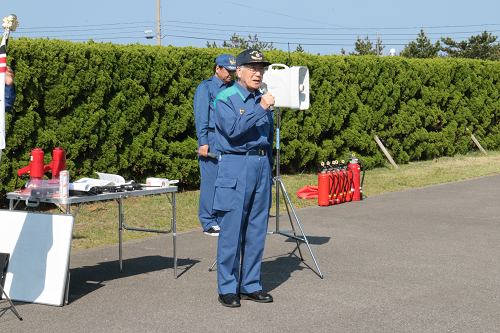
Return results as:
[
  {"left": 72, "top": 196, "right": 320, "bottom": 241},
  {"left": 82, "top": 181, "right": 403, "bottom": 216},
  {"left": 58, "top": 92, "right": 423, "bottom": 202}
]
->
[{"left": 198, "top": 131, "right": 218, "bottom": 231}]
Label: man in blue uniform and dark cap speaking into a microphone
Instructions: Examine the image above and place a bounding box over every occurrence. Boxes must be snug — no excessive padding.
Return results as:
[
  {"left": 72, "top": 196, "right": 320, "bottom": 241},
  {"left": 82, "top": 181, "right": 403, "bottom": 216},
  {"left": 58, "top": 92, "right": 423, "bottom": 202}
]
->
[{"left": 213, "top": 49, "right": 274, "bottom": 307}]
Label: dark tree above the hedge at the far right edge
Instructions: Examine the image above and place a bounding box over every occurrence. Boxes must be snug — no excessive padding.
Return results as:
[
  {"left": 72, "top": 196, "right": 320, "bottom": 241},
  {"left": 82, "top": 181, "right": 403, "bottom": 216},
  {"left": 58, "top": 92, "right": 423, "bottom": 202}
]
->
[{"left": 441, "top": 30, "right": 500, "bottom": 60}]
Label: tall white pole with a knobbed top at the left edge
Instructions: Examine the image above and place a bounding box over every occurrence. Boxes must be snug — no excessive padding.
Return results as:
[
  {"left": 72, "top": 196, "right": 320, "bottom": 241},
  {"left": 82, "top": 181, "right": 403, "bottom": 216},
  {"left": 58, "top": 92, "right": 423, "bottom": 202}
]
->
[{"left": 0, "top": 14, "right": 19, "bottom": 162}]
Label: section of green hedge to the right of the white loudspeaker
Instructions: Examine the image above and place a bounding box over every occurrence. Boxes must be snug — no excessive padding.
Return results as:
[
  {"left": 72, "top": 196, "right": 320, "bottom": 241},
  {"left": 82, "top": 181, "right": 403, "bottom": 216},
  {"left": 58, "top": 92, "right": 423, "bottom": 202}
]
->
[{"left": 273, "top": 55, "right": 500, "bottom": 170}]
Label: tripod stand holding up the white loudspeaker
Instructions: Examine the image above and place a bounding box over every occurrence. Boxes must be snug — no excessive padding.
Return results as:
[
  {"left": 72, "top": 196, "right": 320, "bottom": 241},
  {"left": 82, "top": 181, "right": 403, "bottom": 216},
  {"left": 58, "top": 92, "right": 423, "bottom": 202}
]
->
[{"left": 208, "top": 108, "right": 323, "bottom": 278}]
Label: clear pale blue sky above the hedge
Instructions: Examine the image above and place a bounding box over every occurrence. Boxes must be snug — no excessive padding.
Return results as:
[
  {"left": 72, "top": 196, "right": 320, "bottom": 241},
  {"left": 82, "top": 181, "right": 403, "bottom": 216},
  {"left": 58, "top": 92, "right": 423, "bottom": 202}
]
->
[{"left": 0, "top": 0, "right": 500, "bottom": 55}]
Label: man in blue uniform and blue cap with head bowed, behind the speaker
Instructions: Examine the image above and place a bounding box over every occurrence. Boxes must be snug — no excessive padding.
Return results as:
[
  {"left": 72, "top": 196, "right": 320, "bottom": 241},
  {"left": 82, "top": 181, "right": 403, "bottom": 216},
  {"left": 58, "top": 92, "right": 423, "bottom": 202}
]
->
[{"left": 193, "top": 54, "right": 236, "bottom": 236}]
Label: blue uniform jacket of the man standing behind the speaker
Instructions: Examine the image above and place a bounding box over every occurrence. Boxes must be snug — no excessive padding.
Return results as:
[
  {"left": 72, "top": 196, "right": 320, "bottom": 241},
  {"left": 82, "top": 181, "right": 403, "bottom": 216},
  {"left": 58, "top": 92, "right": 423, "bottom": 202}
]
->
[{"left": 193, "top": 75, "right": 233, "bottom": 146}]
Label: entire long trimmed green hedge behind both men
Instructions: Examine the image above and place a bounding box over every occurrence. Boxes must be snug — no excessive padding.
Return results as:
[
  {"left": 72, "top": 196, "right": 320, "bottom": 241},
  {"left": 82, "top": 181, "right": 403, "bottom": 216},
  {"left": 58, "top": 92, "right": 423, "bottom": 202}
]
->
[{"left": 0, "top": 38, "right": 500, "bottom": 200}]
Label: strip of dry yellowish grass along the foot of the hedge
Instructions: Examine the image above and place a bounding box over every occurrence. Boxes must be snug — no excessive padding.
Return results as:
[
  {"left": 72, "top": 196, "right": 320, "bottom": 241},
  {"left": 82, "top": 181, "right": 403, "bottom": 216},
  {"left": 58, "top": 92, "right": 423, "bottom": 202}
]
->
[{"left": 24, "top": 152, "right": 500, "bottom": 250}]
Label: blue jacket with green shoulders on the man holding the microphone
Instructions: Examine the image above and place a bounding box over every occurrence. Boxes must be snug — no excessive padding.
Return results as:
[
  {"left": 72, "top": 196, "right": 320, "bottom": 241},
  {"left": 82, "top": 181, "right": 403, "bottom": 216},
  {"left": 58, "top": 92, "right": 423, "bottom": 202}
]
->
[{"left": 214, "top": 82, "right": 274, "bottom": 166}]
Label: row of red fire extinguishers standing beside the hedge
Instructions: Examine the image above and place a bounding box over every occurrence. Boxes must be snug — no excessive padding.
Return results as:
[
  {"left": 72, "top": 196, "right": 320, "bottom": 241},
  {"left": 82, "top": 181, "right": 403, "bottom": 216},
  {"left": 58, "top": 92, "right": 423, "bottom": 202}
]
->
[{"left": 318, "top": 154, "right": 365, "bottom": 206}]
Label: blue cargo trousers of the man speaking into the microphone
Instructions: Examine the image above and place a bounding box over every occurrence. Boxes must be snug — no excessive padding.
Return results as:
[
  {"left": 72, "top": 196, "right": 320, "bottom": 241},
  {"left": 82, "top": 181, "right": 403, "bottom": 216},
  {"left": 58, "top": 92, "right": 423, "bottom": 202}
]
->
[{"left": 214, "top": 154, "right": 271, "bottom": 294}]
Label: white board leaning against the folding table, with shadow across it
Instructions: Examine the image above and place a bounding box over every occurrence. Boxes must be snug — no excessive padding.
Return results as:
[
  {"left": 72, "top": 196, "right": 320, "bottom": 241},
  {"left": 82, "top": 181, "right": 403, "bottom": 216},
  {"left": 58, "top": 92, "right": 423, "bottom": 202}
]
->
[{"left": 0, "top": 210, "right": 75, "bottom": 306}]
